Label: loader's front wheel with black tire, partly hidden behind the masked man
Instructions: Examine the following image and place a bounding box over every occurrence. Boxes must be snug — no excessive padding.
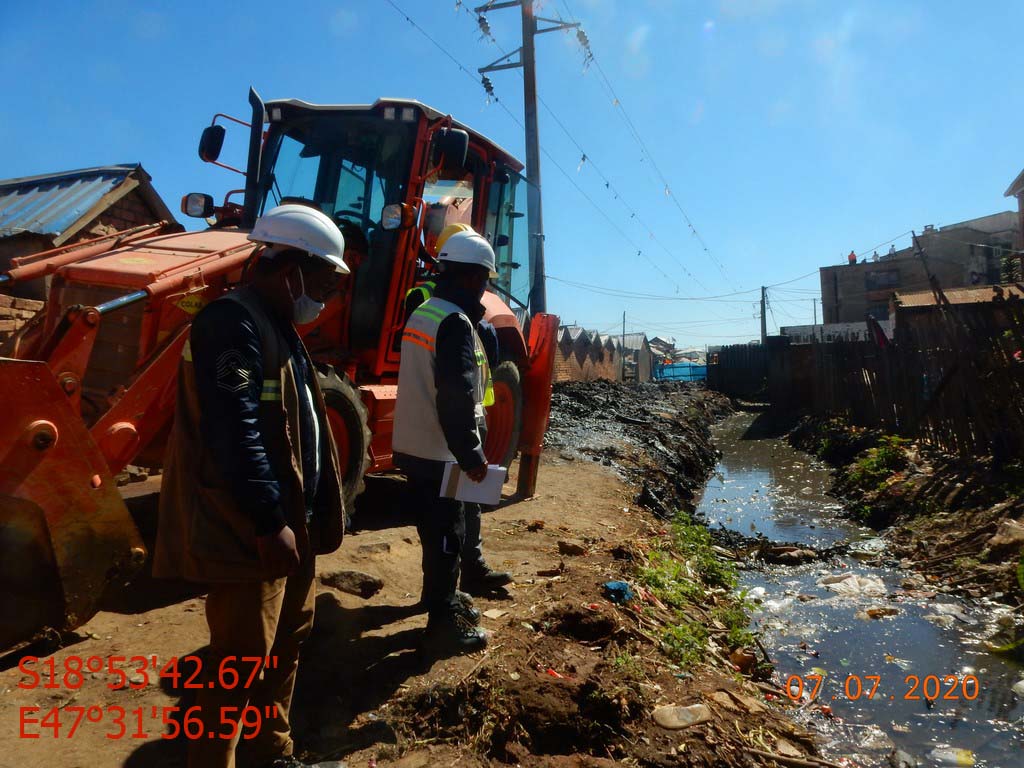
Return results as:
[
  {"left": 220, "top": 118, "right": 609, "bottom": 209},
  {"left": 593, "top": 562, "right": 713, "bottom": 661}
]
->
[{"left": 319, "top": 367, "right": 371, "bottom": 516}]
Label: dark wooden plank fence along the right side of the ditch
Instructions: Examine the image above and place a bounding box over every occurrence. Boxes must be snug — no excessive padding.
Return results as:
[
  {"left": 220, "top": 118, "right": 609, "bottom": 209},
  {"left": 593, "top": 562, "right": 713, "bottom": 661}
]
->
[{"left": 708, "top": 292, "right": 1024, "bottom": 460}]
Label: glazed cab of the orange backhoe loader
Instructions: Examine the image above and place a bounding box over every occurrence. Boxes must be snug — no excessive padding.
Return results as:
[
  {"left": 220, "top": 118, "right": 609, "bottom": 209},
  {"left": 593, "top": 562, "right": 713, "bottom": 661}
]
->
[{"left": 254, "top": 99, "right": 529, "bottom": 380}]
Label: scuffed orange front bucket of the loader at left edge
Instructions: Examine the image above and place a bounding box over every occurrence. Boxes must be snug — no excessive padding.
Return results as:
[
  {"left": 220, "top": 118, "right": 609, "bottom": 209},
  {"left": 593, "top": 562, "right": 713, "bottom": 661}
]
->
[{"left": 0, "top": 358, "right": 145, "bottom": 650}]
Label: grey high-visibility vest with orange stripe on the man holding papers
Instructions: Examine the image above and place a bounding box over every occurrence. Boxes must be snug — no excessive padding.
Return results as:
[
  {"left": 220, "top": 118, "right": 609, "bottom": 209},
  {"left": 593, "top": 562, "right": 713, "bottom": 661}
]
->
[{"left": 391, "top": 296, "right": 494, "bottom": 462}]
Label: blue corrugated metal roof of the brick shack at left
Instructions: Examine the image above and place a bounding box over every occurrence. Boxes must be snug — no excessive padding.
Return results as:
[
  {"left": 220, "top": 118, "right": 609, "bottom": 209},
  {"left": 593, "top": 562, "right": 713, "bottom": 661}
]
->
[{"left": 0, "top": 163, "right": 174, "bottom": 246}]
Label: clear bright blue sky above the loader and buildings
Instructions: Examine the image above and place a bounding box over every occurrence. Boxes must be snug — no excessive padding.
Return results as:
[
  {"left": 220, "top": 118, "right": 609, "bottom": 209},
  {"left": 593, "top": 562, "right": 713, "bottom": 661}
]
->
[{"left": 0, "top": 0, "right": 1024, "bottom": 346}]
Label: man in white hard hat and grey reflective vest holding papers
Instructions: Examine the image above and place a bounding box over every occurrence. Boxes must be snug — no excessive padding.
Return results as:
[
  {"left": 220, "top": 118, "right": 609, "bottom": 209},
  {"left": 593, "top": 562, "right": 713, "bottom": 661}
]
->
[{"left": 392, "top": 231, "right": 496, "bottom": 652}]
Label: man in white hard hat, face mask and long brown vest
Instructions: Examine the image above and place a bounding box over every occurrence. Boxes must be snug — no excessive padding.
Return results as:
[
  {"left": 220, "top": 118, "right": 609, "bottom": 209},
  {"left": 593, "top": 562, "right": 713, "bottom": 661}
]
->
[{"left": 154, "top": 205, "right": 348, "bottom": 768}]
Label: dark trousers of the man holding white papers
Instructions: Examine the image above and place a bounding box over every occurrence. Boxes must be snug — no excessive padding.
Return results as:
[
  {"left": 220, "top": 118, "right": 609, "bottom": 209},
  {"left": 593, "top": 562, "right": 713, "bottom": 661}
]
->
[{"left": 395, "top": 456, "right": 466, "bottom": 621}]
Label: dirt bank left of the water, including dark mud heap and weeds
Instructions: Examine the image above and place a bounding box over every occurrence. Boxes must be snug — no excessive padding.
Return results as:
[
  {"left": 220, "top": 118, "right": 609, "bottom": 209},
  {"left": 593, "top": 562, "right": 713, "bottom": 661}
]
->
[{"left": 0, "top": 383, "right": 830, "bottom": 768}]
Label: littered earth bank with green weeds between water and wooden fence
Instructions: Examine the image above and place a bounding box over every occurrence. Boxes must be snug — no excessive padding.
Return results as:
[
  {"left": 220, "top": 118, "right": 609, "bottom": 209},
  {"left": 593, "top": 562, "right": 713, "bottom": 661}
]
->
[{"left": 790, "top": 418, "right": 1024, "bottom": 605}]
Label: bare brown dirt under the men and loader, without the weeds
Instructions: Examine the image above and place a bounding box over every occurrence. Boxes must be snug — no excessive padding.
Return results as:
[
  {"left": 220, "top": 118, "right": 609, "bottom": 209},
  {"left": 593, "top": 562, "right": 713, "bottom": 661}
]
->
[{"left": 0, "top": 393, "right": 822, "bottom": 768}]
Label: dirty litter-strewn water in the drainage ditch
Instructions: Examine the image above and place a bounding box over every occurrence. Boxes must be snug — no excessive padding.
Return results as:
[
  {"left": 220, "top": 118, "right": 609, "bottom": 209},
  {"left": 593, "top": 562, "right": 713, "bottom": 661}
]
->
[{"left": 698, "top": 414, "right": 1024, "bottom": 768}]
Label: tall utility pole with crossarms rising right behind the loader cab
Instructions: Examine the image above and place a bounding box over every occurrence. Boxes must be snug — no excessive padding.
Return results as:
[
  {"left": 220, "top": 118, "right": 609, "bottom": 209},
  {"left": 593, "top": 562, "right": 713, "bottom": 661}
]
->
[{"left": 473, "top": 0, "right": 580, "bottom": 314}]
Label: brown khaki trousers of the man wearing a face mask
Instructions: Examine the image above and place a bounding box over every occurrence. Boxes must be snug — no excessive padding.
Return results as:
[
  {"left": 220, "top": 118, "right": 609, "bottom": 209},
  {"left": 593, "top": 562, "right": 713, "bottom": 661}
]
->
[{"left": 188, "top": 556, "right": 316, "bottom": 768}]
